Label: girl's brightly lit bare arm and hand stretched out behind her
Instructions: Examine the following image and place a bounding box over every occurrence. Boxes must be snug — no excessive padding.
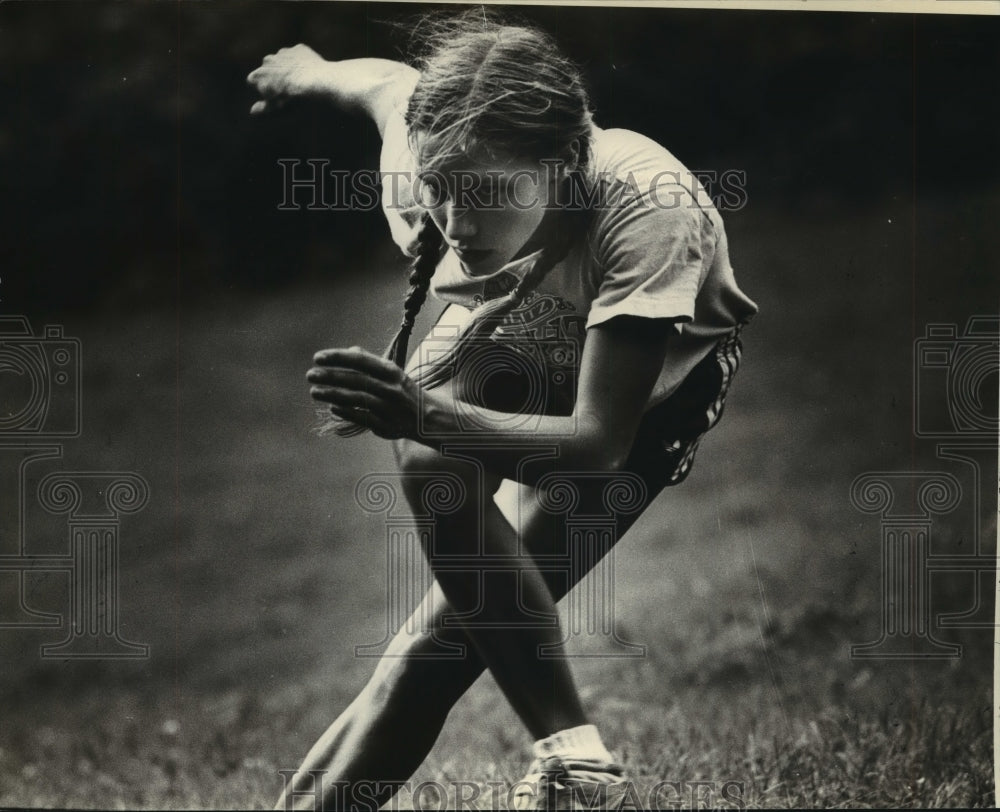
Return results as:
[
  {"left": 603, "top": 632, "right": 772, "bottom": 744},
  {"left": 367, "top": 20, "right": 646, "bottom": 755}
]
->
[{"left": 247, "top": 44, "right": 420, "bottom": 135}]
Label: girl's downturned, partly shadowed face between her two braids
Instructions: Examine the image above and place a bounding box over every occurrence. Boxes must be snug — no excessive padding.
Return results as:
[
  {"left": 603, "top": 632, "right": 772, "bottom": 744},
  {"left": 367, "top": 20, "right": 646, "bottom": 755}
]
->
[{"left": 414, "top": 143, "right": 556, "bottom": 276}]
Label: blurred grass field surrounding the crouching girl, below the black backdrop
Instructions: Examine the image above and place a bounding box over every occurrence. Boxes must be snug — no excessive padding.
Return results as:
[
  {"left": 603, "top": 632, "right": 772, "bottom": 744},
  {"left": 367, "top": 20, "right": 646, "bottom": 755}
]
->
[{"left": 0, "top": 200, "right": 998, "bottom": 808}]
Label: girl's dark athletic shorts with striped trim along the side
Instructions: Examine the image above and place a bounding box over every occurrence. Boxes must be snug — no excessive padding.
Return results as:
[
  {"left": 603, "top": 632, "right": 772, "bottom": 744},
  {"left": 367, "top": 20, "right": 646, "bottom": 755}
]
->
[{"left": 625, "top": 327, "right": 743, "bottom": 494}]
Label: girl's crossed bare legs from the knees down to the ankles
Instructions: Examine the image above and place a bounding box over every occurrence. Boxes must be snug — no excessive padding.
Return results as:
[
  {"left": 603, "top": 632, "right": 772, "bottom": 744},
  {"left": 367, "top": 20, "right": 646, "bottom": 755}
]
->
[{"left": 277, "top": 444, "right": 638, "bottom": 809}]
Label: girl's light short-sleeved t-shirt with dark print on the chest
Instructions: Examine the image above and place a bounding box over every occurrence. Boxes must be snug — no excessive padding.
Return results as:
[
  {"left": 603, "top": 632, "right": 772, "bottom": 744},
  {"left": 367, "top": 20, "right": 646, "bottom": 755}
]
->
[{"left": 381, "top": 116, "right": 757, "bottom": 408}]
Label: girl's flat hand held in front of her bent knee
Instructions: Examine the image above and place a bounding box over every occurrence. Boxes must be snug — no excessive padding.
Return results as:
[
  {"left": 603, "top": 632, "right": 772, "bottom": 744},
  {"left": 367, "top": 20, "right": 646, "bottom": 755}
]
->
[{"left": 306, "top": 347, "right": 428, "bottom": 440}]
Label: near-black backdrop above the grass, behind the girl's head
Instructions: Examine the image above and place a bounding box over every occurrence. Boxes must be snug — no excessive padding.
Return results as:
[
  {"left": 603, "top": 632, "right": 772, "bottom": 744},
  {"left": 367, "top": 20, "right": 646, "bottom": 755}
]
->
[{"left": 0, "top": 3, "right": 1000, "bottom": 312}]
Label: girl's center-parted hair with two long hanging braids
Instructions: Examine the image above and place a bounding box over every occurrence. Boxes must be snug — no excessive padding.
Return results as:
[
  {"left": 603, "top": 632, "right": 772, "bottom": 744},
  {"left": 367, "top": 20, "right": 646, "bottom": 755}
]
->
[{"left": 330, "top": 9, "right": 592, "bottom": 436}]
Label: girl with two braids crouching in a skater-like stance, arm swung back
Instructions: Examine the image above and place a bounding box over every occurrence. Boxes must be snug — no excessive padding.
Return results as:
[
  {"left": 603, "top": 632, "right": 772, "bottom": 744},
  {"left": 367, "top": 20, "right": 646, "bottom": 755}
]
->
[{"left": 249, "top": 10, "right": 756, "bottom": 809}]
